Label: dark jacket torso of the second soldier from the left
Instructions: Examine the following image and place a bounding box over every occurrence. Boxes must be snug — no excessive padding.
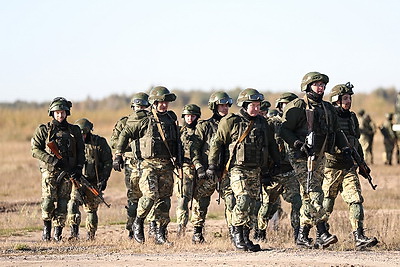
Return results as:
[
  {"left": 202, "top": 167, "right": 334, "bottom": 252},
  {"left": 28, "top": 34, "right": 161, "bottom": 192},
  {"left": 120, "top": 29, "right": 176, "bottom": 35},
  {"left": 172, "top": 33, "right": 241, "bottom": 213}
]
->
[{"left": 84, "top": 134, "right": 112, "bottom": 184}]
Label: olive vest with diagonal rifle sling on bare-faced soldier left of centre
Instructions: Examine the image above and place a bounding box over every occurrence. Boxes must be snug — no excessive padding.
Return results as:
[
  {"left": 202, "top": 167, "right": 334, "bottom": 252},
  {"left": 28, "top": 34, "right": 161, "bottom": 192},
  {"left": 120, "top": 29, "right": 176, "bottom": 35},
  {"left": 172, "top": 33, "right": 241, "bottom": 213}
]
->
[{"left": 139, "top": 112, "right": 178, "bottom": 159}]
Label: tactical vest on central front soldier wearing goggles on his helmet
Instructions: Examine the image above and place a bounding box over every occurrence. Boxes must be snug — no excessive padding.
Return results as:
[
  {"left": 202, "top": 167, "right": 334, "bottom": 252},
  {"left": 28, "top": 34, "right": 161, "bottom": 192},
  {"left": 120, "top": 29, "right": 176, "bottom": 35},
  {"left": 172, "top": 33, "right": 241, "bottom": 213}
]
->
[{"left": 229, "top": 116, "right": 268, "bottom": 167}]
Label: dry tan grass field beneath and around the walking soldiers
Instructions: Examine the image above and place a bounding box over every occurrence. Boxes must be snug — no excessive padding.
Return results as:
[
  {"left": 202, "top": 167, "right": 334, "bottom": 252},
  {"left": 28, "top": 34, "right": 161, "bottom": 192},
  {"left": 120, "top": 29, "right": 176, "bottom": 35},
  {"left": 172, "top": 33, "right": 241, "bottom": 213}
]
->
[{"left": 0, "top": 104, "right": 400, "bottom": 266}]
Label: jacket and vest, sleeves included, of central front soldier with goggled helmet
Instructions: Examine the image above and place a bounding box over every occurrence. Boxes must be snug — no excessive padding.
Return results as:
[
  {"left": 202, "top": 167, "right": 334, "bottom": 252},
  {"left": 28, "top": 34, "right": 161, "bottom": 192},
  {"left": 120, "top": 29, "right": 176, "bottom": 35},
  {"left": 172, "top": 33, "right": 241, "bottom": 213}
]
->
[{"left": 208, "top": 109, "right": 280, "bottom": 169}]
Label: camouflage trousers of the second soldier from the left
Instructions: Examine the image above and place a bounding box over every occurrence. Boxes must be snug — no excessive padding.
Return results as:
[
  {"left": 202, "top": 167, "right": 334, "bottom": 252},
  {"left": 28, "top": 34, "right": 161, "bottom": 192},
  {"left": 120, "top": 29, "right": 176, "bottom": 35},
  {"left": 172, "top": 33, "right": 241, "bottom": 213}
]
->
[{"left": 68, "top": 183, "right": 100, "bottom": 232}]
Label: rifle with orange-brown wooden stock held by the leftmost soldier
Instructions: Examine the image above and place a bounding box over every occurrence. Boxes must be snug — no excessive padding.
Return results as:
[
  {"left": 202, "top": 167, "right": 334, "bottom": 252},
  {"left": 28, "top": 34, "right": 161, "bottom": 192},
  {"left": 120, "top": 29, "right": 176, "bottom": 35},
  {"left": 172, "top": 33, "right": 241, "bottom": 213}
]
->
[{"left": 47, "top": 141, "right": 111, "bottom": 208}]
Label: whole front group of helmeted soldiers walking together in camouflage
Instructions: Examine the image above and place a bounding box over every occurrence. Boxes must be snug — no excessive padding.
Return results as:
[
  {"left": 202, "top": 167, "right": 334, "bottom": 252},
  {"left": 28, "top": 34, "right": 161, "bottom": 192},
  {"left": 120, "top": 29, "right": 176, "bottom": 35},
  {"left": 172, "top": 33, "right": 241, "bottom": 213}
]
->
[{"left": 32, "top": 72, "right": 378, "bottom": 252}]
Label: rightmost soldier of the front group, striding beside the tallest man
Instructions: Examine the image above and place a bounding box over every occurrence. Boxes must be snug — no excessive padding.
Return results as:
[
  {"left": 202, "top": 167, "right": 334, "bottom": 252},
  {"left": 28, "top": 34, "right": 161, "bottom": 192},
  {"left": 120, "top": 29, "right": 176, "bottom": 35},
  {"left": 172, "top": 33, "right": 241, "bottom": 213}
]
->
[{"left": 322, "top": 83, "right": 378, "bottom": 247}]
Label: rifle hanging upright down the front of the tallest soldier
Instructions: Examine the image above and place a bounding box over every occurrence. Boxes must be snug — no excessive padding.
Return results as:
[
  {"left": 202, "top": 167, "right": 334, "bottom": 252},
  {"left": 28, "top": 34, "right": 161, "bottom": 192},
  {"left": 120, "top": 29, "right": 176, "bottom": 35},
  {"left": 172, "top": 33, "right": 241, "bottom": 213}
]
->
[{"left": 304, "top": 109, "right": 315, "bottom": 194}]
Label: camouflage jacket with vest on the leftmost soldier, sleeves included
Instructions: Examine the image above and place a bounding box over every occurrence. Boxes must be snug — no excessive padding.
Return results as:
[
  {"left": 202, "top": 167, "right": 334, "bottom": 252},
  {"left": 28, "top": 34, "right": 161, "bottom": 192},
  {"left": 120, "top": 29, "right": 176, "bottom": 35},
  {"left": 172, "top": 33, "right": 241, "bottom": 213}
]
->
[{"left": 31, "top": 120, "right": 85, "bottom": 172}]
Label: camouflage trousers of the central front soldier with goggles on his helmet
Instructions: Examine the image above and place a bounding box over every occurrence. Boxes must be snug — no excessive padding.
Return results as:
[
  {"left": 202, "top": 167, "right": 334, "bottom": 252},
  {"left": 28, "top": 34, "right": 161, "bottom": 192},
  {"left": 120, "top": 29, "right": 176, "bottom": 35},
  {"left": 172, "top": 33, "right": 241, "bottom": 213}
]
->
[{"left": 230, "top": 166, "right": 260, "bottom": 228}]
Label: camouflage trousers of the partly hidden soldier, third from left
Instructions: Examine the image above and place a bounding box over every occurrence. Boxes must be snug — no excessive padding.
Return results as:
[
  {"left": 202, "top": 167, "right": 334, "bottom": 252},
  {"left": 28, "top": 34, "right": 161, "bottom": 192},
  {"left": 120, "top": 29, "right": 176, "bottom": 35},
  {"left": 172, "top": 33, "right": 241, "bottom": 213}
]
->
[{"left": 124, "top": 157, "right": 142, "bottom": 230}]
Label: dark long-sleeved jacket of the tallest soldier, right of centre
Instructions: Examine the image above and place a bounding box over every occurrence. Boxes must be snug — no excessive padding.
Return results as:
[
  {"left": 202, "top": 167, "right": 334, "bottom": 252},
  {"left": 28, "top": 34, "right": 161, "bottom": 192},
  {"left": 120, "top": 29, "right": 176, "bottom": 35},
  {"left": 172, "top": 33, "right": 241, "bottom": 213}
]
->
[{"left": 281, "top": 96, "right": 346, "bottom": 158}]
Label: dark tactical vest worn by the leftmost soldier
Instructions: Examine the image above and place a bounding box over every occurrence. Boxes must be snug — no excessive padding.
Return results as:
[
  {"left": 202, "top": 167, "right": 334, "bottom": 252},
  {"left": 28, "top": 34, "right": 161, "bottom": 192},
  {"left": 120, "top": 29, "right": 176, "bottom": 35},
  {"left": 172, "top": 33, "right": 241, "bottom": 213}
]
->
[{"left": 40, "top": 122, "right": 77, "bottom": 171}]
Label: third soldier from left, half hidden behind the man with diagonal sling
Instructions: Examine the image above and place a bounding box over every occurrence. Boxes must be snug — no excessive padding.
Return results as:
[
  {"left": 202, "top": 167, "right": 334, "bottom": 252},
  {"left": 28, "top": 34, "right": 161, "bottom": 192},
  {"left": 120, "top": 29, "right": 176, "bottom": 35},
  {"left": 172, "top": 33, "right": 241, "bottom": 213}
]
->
[{"left": 111, "top": 92, "right": 149, "bottom": 238}]
